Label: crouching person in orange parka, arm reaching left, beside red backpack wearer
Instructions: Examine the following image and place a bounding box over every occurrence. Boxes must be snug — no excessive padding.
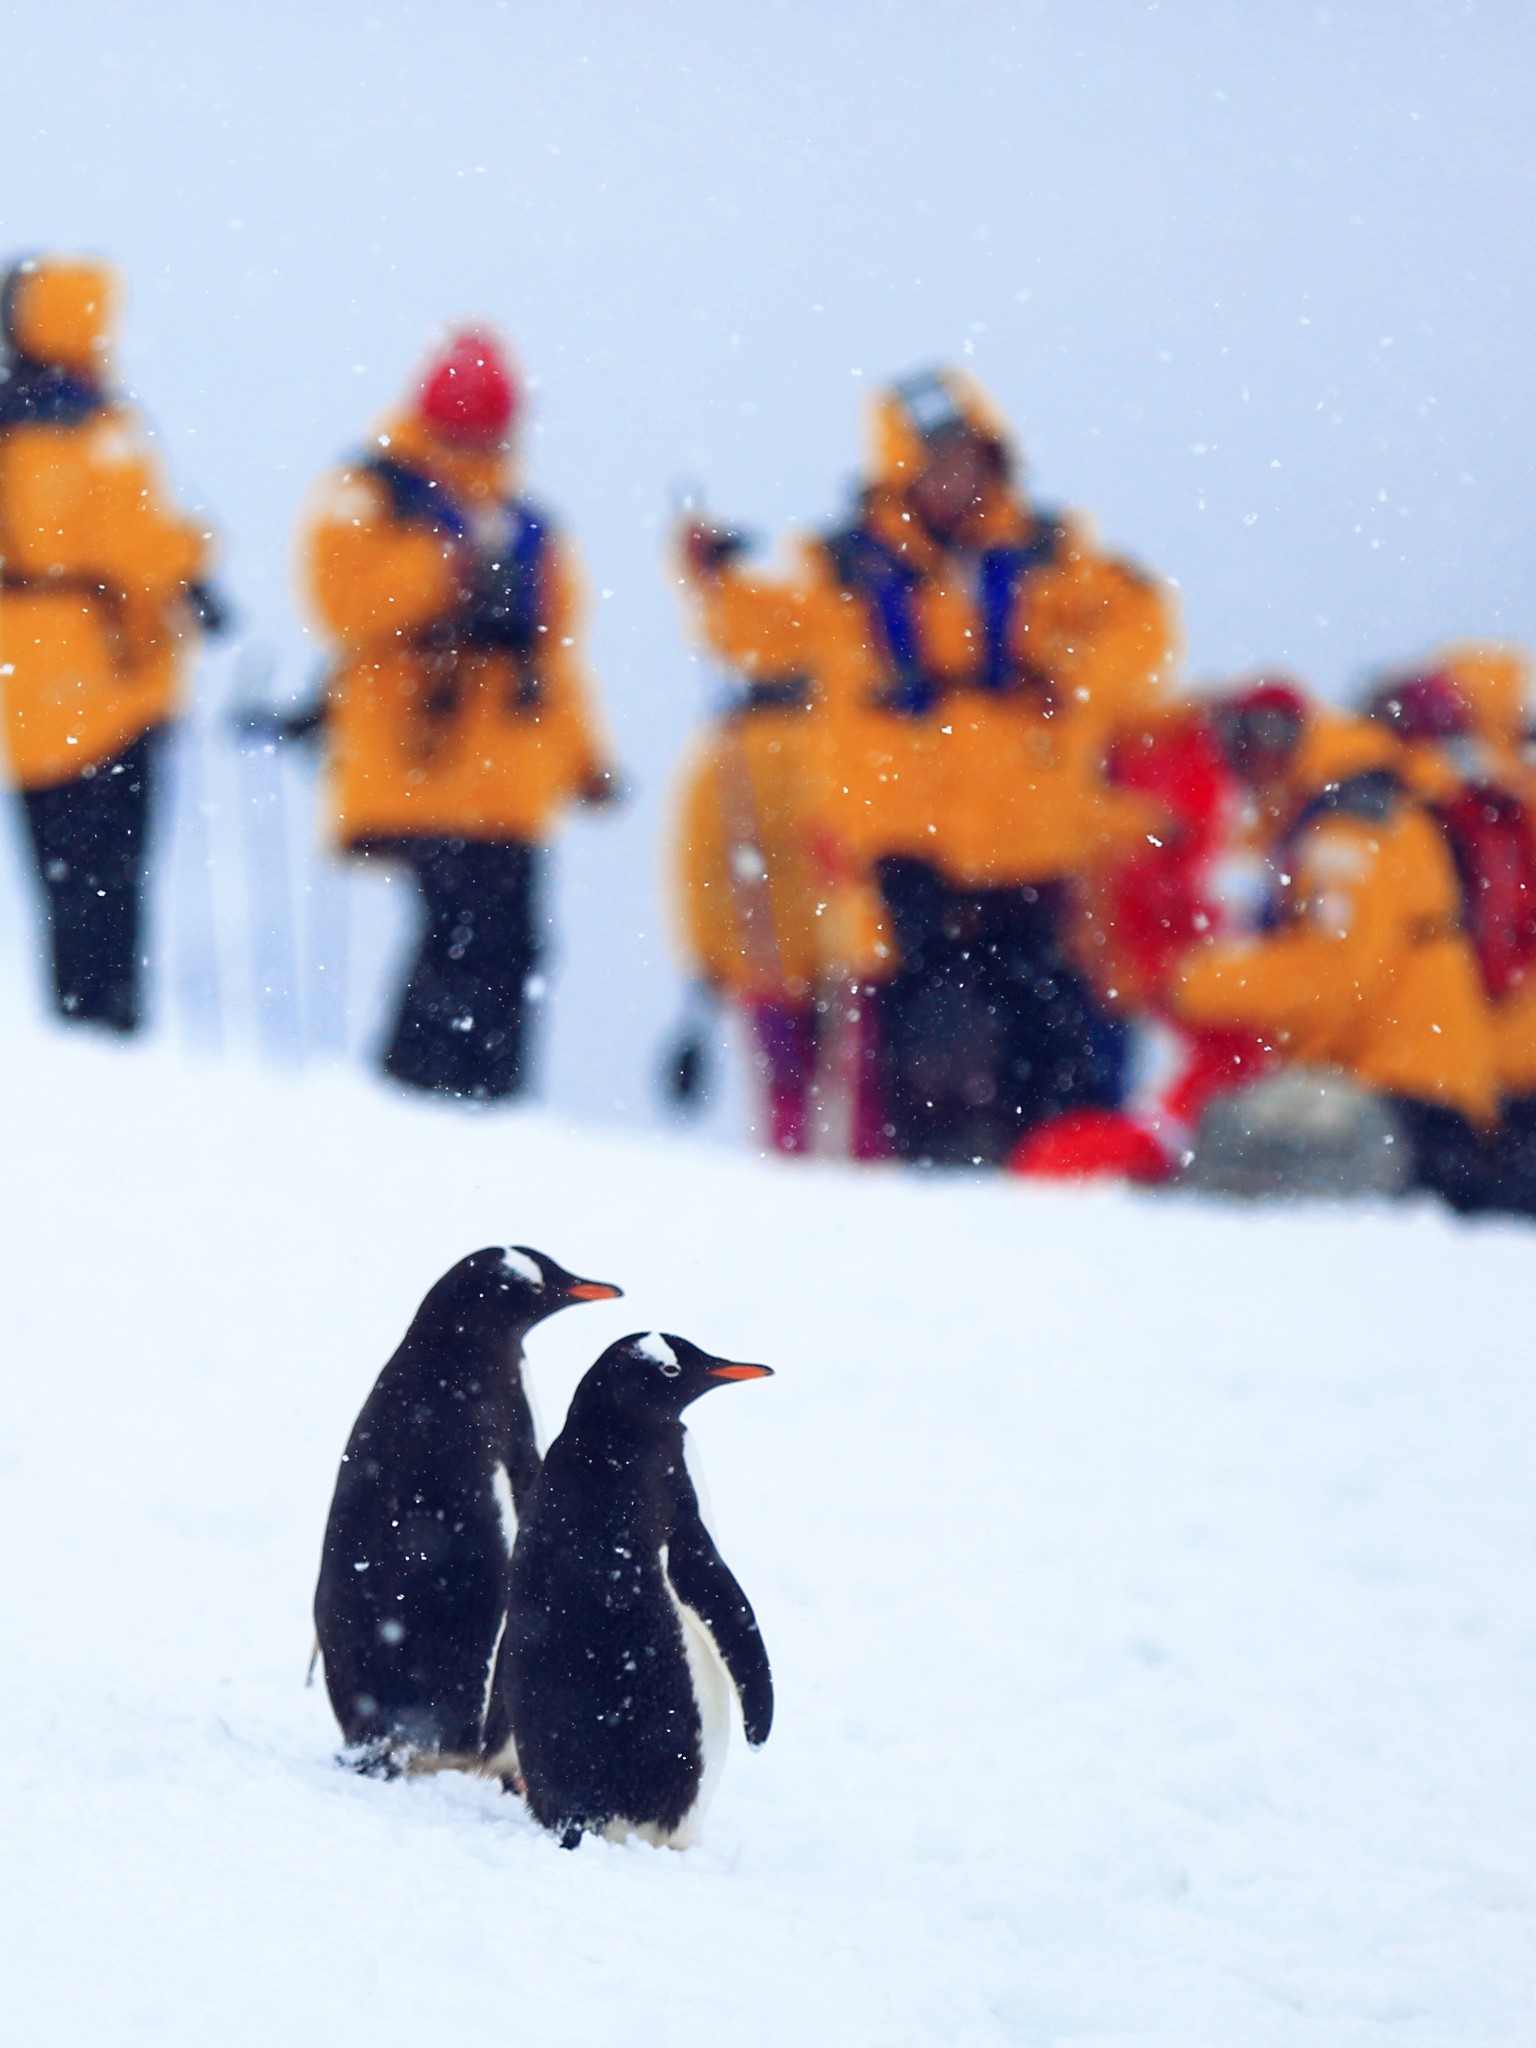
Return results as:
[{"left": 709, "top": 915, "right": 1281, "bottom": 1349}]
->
[{"left": 1174, "top": 713, "right": 1499, "bottom": 1210}]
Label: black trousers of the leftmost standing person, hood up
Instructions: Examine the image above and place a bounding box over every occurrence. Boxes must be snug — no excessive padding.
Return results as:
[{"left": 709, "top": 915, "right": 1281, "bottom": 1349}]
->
[{"left": 23, "top": 731, "right": 164, "bottom": 1032}]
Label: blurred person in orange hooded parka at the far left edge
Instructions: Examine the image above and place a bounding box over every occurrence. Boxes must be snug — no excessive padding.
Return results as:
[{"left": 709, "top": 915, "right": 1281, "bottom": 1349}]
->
[{"left": 0, "top": 256, "right": 221, "bottom": 1032}]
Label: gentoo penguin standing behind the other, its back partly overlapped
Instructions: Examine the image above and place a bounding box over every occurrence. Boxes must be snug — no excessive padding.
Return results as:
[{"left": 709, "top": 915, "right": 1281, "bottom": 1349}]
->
[{"left": 315, "top": 1245, "right": 621, "bottom": 1776}]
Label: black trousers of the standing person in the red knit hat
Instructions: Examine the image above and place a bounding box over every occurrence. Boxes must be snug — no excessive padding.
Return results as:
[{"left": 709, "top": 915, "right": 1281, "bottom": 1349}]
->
[{"left": 369, "top": 838, "right": 541, "bottom": 1102}]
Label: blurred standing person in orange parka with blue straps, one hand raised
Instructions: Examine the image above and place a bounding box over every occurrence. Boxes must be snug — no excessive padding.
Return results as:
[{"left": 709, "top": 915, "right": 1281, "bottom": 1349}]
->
[{"left": 684, "top": 371, "right": 1174, "bottom": 1161}]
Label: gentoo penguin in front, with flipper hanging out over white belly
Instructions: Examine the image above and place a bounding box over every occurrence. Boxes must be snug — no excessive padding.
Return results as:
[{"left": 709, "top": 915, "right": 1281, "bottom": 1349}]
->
[{"left": 485, "top": 1331, "right": 774, "bottom": 1849}]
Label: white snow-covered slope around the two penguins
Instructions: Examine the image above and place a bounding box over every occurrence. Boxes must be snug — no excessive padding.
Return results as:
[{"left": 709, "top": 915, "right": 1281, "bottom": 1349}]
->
[{"left": 0, "top": 1028, "right": 1536, "bottom": 2048}]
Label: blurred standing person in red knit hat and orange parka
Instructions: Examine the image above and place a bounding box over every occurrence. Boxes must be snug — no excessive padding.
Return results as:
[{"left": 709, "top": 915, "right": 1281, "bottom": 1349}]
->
[{"left": 303, "top": 330, "right": 616, "bottom": 1102}]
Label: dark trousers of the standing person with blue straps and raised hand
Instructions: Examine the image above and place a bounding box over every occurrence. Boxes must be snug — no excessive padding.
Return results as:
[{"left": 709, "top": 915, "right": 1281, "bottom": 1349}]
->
[{"left": 877, "top": 856, "right": 1122, "bottom": 1165}]
